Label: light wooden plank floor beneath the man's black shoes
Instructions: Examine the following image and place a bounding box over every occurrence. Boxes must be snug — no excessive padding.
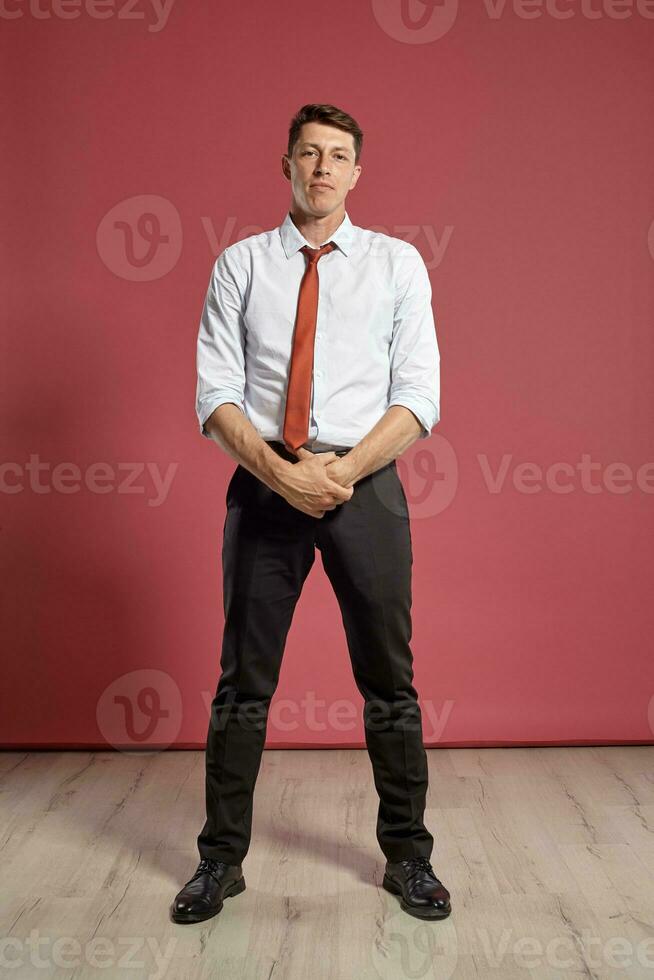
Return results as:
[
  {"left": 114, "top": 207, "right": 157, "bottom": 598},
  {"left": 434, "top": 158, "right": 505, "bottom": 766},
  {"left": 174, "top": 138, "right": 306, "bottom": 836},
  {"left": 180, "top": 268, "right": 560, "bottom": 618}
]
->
[{"left": 0, "top": 746, "right": 654, "bottom": 980}]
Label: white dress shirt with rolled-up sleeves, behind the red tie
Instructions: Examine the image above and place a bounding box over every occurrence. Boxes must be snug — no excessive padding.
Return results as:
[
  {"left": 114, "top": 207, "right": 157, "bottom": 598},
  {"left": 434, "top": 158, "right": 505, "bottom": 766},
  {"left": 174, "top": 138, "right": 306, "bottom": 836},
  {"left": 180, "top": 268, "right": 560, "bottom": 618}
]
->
[{"left": 196, "top": 212, "right": 440, "bottom": 452}]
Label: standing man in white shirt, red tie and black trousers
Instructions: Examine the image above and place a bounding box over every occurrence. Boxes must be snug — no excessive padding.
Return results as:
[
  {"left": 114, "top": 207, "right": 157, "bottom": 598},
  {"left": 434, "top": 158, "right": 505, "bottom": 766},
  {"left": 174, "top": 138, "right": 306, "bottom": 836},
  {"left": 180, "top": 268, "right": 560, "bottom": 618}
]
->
[{"left": 171, "top": 104, "right": 450, "bottom": 922}]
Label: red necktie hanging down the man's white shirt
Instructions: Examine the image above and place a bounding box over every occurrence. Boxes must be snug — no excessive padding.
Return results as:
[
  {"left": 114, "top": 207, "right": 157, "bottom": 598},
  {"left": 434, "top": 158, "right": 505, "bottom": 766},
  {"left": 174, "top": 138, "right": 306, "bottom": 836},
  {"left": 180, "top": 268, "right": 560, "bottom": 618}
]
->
[{"left": 284, "top": 242, "right": 336, "bottom": 452}]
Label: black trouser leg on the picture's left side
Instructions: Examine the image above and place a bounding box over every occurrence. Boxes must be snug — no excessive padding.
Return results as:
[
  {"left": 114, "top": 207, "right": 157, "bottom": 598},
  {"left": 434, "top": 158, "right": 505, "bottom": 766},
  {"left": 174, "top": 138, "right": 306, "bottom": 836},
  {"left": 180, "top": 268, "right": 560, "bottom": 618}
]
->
[{"left": 197, "top": 466, "right": 315, "bottom": 864}]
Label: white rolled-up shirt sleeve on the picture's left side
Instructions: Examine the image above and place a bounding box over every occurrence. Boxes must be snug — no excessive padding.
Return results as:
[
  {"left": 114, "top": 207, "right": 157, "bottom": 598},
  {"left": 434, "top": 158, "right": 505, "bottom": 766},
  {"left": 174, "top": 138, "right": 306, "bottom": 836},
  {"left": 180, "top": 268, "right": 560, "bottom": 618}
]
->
[{"left": 195, "top": 248, "right": 245, "bottom": 439}]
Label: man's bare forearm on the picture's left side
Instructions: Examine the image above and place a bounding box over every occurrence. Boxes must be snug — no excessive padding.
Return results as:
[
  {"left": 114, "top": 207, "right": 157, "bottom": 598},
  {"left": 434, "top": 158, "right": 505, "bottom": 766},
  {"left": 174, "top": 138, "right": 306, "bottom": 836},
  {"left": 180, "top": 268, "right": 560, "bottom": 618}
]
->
[{"left": 205, "top": 402, "right": 293, "bottom": 493}]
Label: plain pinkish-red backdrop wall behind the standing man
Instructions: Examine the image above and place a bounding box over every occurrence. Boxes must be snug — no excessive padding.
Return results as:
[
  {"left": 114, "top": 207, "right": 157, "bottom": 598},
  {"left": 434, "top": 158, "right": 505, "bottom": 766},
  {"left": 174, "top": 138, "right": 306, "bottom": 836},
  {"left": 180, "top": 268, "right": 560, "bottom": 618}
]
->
[{"left": 0, "top": 0, "right": 654, "bottom": 749}]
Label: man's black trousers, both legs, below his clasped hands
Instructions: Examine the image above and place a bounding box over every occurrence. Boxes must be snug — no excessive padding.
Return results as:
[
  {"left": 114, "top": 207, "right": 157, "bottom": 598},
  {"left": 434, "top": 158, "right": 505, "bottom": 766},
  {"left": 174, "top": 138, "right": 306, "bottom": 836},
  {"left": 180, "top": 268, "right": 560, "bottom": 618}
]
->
[{"left": 197, "top": 443, "right": 434, "bottom": 864}]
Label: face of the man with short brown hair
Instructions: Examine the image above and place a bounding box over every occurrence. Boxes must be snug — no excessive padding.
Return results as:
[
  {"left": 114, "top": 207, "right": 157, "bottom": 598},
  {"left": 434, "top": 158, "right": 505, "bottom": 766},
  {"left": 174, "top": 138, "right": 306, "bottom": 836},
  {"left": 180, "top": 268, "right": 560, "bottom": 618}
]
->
[{"left": 282, "top": 122, "right": 361, "bottom": 216}]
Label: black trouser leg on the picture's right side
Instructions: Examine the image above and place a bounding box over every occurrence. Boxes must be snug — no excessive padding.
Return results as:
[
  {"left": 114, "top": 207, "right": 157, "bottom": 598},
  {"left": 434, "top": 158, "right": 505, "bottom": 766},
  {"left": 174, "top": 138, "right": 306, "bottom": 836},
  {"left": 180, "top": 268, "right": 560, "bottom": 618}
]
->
[{"left": 316, "top": 462, "right": 434, "bottom": 861}]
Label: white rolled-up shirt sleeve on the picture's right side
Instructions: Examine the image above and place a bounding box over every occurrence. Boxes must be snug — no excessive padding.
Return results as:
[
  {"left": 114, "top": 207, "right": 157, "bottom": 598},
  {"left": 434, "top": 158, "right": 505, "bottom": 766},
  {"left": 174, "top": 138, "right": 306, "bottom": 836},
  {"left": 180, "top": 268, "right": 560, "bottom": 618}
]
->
[{"left": 388, "top": 243, "right": 440, "bottom": 439}]
